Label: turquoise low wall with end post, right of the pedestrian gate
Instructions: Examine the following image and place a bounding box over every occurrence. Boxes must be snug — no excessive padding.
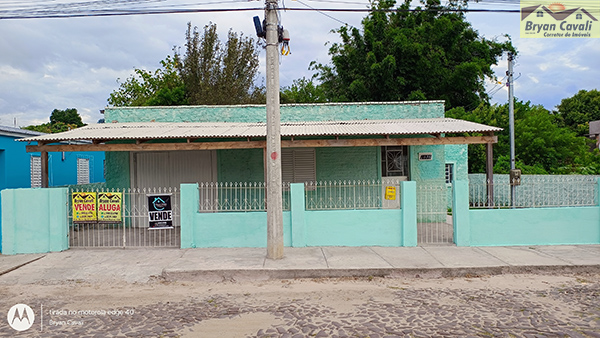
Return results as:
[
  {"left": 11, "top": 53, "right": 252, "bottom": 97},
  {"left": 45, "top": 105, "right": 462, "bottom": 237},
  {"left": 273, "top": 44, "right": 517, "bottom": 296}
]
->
[{"left": 453, "top": 181, "right": 600, "bottom": 246}]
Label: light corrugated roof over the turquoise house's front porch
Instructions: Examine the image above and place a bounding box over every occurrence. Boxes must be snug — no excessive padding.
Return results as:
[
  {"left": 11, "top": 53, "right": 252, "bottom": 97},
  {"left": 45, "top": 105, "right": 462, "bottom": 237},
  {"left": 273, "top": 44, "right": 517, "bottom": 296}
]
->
[{"left": 20, "top": 118, "right": 502, "bottom": 142}]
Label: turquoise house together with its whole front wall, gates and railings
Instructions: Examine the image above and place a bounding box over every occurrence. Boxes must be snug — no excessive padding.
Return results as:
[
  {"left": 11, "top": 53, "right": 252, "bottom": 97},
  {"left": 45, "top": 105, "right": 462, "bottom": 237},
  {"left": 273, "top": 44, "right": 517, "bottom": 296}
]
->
[{"left": 2, "top": 101, "right": 600, "bottom": 254}]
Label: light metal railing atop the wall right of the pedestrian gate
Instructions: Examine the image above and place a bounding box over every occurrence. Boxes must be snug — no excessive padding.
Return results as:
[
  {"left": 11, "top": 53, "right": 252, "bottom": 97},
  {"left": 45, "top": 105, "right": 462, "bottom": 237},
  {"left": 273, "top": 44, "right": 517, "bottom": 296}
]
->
[{"left": 469, "top": 175, "right": 598, "bottom": 208}]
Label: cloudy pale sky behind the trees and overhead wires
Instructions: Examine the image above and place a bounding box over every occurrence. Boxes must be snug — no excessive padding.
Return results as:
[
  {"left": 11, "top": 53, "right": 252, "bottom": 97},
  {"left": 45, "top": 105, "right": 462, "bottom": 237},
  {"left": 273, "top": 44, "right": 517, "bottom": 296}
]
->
[{"left": 0, "top": 0, "right": 600, "bottom": 126}]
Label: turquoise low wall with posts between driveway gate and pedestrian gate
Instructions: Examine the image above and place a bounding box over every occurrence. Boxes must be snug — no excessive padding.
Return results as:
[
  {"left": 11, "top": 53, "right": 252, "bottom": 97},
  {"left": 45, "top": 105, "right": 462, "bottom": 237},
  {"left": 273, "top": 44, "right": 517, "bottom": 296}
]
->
[{"left": 181, "top": 182, "right": 417, "bottom": 248}]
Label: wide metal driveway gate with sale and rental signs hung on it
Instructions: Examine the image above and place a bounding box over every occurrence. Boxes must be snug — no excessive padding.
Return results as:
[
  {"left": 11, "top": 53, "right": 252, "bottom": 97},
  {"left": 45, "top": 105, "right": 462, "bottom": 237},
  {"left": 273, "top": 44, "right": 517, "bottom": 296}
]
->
[{"left": 67, "top": 185, "right": 181, "bottom": 247}]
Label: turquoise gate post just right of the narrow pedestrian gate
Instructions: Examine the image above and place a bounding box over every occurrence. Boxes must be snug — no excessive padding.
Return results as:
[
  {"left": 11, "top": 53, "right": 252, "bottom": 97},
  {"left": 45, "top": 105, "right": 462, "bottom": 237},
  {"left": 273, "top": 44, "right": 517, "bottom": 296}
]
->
[{"left": 452, "top": 181, "right": 471, "bottom": 246}]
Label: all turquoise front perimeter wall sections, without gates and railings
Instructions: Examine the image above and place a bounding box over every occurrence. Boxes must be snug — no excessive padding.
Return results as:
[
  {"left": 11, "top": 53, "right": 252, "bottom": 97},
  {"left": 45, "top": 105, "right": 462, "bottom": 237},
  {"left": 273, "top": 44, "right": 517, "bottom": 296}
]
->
[{"left": 0, "top": 181, "right": 600, "bottom": 255}]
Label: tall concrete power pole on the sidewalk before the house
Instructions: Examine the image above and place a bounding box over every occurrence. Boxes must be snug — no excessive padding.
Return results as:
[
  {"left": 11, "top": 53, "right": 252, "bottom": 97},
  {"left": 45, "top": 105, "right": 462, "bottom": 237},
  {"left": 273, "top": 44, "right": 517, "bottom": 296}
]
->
[{"left": 265, "top": 0, "right": 283, "bottom": 259}]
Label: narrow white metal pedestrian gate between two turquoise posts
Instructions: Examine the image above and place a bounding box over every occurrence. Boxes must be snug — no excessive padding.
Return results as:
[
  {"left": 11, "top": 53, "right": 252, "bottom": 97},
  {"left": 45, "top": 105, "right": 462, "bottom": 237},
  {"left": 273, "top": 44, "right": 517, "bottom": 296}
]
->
[{"left": 417, "top": 181, "right": 454, "bottom": 245}]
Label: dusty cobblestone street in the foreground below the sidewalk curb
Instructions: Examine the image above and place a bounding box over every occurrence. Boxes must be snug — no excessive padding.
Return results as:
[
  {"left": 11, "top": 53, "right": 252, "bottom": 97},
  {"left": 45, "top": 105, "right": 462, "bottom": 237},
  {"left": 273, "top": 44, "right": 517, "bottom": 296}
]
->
[{"left": 0, "top": 274, "right": 600, "bottom": 338}]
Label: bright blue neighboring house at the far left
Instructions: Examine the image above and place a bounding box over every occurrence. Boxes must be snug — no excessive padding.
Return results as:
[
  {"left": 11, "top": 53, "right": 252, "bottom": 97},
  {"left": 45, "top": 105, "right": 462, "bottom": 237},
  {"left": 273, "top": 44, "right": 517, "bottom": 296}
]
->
[{"left": 0, "top": 126, "right": 105, "bottom": 252}]
